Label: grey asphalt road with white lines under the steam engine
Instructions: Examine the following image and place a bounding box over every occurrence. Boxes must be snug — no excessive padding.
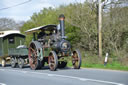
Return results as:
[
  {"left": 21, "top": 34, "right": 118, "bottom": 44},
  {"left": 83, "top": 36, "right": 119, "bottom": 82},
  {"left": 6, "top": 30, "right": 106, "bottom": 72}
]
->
[{"left": 0, "top": 66, "right": 128, "bottom": 85}]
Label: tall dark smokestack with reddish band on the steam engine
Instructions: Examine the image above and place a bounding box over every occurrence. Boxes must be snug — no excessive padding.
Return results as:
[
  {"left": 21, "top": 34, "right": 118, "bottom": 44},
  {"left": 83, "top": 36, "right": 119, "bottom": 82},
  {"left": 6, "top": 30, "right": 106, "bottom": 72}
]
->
[{"left": 59, "top": 14, "right": 65, "bottom": 39}]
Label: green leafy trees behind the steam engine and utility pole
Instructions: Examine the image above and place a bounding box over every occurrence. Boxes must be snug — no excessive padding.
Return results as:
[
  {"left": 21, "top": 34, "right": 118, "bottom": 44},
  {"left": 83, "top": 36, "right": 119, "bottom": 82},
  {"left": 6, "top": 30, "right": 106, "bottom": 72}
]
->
[{"left": 21, "top": 0, "right": 128, "bottom": 57}]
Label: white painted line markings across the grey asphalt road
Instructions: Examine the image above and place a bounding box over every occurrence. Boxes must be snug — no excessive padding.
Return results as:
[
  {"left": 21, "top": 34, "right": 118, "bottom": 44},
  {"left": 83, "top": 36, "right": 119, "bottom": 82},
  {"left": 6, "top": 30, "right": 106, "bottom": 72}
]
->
[{"left": 0, "top": 69, "right": 124, "bottom": 85}]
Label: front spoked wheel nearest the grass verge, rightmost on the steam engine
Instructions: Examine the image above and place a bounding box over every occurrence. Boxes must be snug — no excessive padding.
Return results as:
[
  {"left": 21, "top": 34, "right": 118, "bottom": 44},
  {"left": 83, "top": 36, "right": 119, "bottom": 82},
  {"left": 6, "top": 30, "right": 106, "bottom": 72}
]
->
[{"left": 72, "top": 50, "right": 81, "bottom": 69}]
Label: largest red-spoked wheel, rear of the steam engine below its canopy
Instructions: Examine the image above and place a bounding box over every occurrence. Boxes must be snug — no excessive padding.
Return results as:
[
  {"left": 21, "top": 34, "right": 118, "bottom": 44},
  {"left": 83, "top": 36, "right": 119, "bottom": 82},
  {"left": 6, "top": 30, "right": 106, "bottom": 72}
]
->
[{"left": 29, "top": 43, "right": 41, "bottom": 70}]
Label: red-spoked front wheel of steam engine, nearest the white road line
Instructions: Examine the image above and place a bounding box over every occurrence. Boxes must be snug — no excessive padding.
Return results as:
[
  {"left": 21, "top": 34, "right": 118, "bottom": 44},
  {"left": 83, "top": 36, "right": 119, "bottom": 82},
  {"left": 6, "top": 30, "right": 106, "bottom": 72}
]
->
[{"left": 48, "top": 51, "right": 58, "bottom": 71}]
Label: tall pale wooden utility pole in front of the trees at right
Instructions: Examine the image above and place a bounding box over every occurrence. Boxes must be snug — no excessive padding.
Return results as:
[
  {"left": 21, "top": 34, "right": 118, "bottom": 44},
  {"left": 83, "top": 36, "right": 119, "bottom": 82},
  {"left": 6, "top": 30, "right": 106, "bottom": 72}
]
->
[{"left": 98, "top": 0, "right": 102, "bottom": 58}]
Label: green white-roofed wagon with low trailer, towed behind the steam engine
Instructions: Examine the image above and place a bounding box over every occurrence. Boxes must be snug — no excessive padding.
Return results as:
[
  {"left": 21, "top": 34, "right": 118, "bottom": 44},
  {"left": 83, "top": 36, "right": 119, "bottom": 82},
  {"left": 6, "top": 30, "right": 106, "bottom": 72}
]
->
[{"left": 0, "top": 30, "right": 28, "bottom": 68}]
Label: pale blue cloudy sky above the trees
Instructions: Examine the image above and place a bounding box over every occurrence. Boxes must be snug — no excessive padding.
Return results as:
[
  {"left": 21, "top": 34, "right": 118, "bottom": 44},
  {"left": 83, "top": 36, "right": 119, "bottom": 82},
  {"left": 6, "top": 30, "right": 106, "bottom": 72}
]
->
[{"left": 0, "top": 0, "right": 85, "bottom": 21}]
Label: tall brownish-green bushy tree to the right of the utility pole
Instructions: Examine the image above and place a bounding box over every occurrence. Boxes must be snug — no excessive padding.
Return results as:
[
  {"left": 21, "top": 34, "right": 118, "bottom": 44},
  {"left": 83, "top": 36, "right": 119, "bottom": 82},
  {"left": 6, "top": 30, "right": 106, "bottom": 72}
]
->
[{"left": 103, "top": 3, "right": 128, "bottom": 57}]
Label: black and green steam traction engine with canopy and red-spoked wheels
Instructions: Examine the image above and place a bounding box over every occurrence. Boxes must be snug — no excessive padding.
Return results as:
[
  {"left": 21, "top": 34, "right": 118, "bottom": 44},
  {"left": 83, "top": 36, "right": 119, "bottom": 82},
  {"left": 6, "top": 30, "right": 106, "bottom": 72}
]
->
[{"left": 26, "top": 15, "right": 81, "bottom": 71}]
